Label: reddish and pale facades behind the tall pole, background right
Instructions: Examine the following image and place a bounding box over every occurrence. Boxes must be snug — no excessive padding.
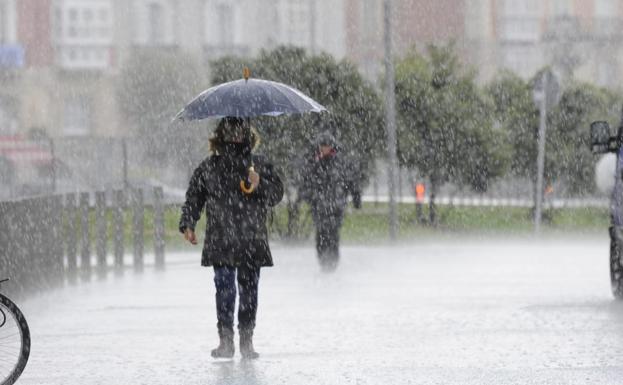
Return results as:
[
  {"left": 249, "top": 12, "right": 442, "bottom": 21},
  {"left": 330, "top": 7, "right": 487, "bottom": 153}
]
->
[{"left": 346, "top": 0, "right": 623, "bottom": 87}]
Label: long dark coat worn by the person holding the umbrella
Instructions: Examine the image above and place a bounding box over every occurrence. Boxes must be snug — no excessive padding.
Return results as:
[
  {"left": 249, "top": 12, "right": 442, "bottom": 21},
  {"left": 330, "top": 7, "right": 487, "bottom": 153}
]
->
[{"left": 179, "top": 147, "right": 283, "bottom": 267}]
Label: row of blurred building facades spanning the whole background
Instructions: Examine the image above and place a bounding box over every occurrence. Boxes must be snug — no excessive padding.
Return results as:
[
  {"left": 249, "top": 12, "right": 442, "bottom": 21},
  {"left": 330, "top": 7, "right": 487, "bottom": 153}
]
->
[{"left": 0, "top": 0, "right": 623, "bottom": 136}]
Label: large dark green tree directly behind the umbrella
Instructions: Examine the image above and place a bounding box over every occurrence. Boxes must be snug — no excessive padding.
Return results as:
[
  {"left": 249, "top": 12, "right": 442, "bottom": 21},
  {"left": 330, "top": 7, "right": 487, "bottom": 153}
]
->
[{"left": 211, "top": 47, "right": 383, "bottom": 237}]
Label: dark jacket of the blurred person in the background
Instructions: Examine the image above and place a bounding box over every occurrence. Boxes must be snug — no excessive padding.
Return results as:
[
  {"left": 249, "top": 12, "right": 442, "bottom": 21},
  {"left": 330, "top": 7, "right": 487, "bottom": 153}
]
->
[{"left": 298, "top": 147, "right": 361, "bottom": 215}]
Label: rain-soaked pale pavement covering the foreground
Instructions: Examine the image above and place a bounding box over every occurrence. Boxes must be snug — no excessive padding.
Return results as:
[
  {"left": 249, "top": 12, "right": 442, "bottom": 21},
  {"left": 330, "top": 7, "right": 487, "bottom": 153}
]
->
[{"left": 13, "top": 237, "right": 623, "bottom": 385}]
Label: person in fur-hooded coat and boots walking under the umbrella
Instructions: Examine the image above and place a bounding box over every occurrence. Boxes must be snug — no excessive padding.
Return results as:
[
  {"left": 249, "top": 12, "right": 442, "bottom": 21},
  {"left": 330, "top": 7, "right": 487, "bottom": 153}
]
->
[{"left": 179, "top": 117, "right": 283, "bottom": 358}]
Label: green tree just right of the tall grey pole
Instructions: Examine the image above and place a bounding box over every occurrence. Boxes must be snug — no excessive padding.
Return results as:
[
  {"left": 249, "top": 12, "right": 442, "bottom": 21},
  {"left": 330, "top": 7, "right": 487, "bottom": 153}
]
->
[{"left": 396, "top": 46, "right": 507, "bottom": 224}]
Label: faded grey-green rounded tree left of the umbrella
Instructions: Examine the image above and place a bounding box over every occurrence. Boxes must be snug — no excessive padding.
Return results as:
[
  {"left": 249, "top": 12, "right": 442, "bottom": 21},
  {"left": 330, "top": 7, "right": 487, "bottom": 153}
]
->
[{"left": 117, "top": 49, "right": 203, "bottom": 164}]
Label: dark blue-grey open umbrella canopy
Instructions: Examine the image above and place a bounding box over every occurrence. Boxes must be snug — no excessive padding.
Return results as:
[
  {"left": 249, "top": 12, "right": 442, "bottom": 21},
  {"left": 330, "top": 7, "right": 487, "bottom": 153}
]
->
[{"left": 174, "top": 79, "right": 327, "bottom": 121}]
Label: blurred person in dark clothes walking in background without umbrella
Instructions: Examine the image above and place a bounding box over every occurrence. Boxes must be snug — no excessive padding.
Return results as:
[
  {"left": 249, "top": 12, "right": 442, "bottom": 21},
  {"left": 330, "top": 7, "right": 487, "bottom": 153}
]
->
[{"left": 298, "top": 131, "right": 361, "bottom": 271}]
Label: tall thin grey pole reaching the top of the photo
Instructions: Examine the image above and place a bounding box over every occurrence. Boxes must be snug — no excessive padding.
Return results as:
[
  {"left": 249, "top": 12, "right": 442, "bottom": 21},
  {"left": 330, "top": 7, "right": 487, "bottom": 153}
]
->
[{"left": 383, "top": 0, "right": 398, "bottom": 239}]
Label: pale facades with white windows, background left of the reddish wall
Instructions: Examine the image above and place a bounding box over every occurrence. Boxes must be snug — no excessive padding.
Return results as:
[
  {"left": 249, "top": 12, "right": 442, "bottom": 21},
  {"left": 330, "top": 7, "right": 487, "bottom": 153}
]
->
[{"left": 0, "top": 0, "right": 347, "bottom": 136}]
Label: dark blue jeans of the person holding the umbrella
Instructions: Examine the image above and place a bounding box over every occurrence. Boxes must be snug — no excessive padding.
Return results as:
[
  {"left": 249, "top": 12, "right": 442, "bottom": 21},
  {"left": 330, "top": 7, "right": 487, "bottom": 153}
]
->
[{"left": 214, "top": 266, "right": 260, "bottom": 330}]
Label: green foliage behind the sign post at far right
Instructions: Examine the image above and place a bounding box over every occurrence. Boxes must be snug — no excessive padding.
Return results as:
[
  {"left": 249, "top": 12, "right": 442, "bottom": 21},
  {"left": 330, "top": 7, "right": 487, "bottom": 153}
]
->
[{"left": 486, "top": 72, "right": 619, "bottom": 198}]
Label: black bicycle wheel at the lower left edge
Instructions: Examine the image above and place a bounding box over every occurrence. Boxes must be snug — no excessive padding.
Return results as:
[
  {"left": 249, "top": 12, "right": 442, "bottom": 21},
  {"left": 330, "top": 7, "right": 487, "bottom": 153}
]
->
[{"left": 0, "top": 294, "right": 30, "bottom": 385}]
